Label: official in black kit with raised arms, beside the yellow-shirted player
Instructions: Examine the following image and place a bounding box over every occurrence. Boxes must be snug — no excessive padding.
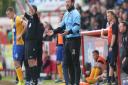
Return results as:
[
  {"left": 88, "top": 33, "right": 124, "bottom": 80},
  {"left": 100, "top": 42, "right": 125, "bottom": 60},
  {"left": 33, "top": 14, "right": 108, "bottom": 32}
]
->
[{"left": 21, "top": 0, "right": 44, "bottom": 85}]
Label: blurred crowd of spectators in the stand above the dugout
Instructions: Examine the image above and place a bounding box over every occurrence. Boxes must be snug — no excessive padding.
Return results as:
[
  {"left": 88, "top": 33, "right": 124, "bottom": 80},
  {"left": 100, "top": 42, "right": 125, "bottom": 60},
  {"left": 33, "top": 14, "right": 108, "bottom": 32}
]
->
[{"left": 76, "top": 0, "right": 128, "bottom": 31}]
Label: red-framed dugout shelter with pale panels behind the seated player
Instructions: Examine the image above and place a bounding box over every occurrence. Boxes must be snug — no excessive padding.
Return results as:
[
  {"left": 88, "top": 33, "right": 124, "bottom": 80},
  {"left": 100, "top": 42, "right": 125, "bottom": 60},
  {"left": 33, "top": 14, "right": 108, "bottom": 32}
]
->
[{"left": 81, "top": 29, "right": 121, "bottom": 85}]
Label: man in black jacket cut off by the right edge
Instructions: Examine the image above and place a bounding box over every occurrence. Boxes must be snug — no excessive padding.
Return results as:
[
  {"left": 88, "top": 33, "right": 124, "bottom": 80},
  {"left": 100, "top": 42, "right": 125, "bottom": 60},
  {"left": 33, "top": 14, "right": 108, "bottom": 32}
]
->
[{"left": 119, "top": 22, "right": 128, "bottom": 74}]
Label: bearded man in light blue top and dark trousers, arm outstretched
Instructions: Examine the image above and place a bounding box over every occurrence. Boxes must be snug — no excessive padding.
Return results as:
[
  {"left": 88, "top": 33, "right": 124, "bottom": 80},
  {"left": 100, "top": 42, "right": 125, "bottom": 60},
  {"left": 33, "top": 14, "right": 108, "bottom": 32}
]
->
[{"left": 48, "top": 0, "right": 81, "bottom": 85}]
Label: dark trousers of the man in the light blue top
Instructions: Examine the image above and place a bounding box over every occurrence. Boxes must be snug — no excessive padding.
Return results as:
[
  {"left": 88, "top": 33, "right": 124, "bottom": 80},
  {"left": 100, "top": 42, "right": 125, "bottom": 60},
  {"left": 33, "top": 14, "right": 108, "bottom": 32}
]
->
[{"left": 63, "top": 38, "right": 81, "bottom": 85}]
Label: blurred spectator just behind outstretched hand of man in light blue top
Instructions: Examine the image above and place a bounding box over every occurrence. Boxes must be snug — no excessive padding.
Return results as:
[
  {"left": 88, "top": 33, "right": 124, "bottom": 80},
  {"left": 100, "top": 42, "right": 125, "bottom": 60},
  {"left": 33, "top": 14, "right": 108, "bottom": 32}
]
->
[{"left": 43, "top": 22, "right": 53, "bottom": 41}]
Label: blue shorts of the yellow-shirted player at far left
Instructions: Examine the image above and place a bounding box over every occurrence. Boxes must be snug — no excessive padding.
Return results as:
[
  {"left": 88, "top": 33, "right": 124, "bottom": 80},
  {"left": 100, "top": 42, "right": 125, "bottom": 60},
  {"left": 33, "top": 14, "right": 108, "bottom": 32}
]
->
[{"left": 13, "top": 45, "right": 24, "bottom": 61}]
